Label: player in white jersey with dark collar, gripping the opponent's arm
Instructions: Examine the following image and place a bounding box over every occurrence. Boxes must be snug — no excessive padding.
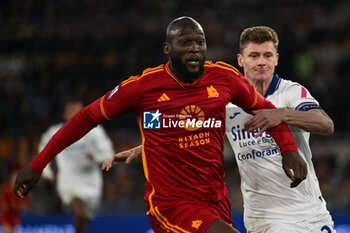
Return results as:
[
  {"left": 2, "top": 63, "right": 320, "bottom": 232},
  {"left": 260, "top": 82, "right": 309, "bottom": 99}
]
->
[{"left": 226, "top": 26, "right": 335, "bottom": 233}]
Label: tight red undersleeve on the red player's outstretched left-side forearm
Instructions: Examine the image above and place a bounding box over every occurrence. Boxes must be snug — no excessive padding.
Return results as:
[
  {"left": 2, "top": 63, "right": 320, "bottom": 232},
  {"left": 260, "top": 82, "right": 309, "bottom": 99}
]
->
[{"left": 29, "top": 98, "right": 104, "bottom": 174}]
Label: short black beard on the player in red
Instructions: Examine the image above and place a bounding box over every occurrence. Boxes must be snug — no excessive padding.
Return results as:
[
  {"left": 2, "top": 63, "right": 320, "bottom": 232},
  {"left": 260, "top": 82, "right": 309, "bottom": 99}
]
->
[{"left": 170, "top": 56, "right": 205, "bottom": 83}]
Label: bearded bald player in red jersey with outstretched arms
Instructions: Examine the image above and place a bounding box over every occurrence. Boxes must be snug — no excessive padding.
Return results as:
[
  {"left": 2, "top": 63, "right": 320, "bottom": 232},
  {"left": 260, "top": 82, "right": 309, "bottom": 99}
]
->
[{"left": 14, "top": 17, "right": 307, "bottom": 233}]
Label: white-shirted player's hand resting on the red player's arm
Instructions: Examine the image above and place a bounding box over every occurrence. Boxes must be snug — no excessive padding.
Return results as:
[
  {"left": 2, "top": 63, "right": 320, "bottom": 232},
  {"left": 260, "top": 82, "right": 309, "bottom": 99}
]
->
[{"left": 244, "top": 109, "right": 284, "bottom": 137}]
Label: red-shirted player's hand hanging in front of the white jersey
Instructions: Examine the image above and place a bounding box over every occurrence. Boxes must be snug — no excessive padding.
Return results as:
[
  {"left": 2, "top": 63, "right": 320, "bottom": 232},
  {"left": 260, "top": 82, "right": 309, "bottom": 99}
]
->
[{"left": 282, "top": 151, "right": 307, "bottom": 188}]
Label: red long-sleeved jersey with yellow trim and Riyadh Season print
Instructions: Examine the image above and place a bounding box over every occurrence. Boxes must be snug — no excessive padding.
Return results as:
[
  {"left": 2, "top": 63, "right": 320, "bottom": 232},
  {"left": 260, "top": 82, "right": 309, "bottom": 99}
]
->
[{"left": 30, "top": 61, "right": 297, "bottom": 232}]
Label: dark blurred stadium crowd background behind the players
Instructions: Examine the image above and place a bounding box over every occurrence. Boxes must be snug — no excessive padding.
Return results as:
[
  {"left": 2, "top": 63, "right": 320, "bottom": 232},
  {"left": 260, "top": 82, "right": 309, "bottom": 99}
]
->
[{"left": 0, "top": 0, "right": 350, "bottom": 232}]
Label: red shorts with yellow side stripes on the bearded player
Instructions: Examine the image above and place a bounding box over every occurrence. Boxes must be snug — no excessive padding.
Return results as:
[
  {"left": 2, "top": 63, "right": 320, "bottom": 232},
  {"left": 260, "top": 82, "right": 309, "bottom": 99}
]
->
[{"left": 148, "top": 196, "right": 233, "bottom": 233}]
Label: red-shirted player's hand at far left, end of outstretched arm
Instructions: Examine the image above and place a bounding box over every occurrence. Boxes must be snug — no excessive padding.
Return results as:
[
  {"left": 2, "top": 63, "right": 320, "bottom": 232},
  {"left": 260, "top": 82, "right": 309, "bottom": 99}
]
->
[{"left": 13, "top": 166, "right": 41, "bottom": 198}]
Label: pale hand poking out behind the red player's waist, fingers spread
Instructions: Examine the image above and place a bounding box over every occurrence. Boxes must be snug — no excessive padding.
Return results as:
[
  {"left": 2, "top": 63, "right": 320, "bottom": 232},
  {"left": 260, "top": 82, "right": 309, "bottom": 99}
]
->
[{"left": 101, "top": 146, "right": 142, "bottom": 171}]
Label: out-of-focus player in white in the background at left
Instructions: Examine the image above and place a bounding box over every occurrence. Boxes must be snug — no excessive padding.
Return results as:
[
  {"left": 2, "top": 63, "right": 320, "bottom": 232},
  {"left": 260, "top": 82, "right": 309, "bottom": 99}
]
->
[{"left": 39, "top": 100, "right": 114, "bottom": 233}]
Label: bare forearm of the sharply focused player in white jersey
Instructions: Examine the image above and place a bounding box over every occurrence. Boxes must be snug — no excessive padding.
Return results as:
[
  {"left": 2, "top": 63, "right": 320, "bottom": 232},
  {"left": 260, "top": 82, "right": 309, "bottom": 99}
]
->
[{"left": 278, "top": 109, "right": 334, "bottom": 135}]
